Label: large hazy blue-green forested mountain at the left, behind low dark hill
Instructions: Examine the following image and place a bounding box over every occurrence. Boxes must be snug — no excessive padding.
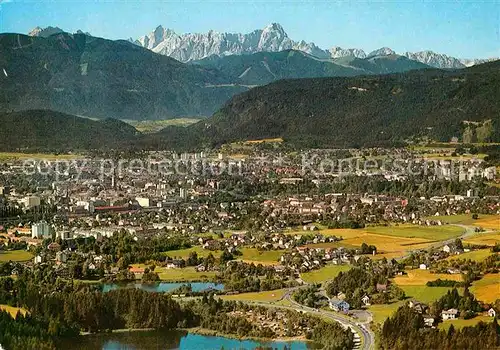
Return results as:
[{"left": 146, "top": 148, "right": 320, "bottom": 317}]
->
[{"left": 0, "top": 32, "right": 247, "bottom": 119}]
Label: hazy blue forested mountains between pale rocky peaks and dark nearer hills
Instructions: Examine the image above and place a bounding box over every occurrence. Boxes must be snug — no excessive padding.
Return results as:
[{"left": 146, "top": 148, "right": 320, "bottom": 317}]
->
[{"left": 0, "top": 27, "right": 436, "bottom": 120}]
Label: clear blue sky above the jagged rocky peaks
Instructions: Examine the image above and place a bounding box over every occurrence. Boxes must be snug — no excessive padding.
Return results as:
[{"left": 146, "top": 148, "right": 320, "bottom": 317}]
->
[{"left": 0, "top": 0, "right": 500, "bottom": 58}]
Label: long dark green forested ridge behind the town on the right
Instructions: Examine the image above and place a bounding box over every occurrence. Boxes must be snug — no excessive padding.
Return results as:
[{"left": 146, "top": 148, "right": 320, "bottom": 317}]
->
[{"left": 173, "top": 61, "right": 500, "bottom": 147}]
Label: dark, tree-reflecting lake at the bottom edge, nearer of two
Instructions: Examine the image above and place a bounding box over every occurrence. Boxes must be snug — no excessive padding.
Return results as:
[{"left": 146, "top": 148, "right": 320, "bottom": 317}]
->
[{"left": 57, "top": 331, "right": 312, "bottom": 350}]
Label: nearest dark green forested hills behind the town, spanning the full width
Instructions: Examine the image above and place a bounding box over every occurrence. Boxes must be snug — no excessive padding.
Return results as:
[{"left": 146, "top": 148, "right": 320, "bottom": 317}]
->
[{"left": 0, "top": 60, "right": 500, "bottom": 152}]
